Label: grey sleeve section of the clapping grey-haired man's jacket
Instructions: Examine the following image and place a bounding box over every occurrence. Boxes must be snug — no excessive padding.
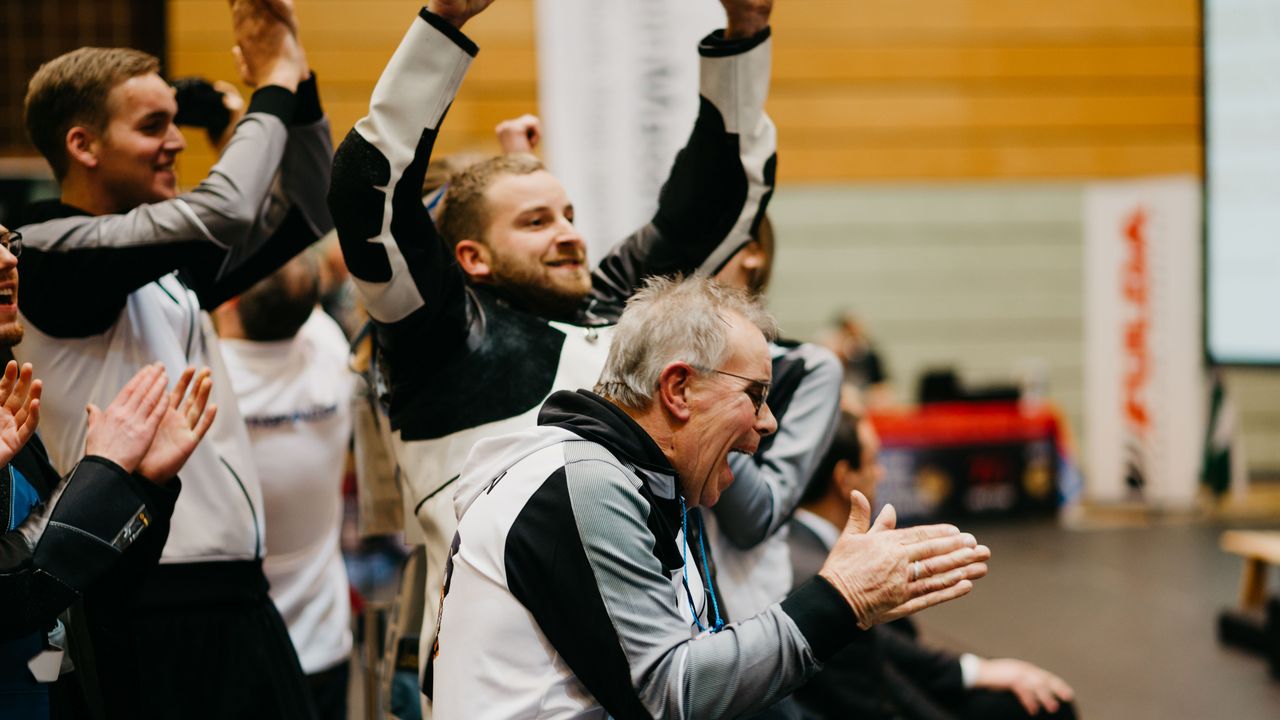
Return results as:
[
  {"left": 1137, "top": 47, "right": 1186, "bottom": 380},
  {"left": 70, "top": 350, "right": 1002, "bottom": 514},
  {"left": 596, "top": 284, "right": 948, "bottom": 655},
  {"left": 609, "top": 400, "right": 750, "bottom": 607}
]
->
[{"left": 557, "top": 453, "right": 824, "bottom": 719}]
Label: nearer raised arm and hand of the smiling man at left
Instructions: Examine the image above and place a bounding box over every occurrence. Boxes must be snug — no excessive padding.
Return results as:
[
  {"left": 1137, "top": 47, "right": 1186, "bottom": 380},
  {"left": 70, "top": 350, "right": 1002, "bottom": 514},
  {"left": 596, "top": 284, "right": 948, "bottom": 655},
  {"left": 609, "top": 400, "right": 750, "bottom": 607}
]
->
[{"left": 19, "top": 0, "right": 312, "bottom": 337}]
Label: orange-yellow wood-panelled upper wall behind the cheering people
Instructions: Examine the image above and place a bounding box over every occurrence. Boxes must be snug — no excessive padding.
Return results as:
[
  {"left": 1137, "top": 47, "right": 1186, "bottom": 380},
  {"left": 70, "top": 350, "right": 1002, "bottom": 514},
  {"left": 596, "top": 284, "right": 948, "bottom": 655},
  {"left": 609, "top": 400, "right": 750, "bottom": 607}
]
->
[{"left": 169, "top": 0, "right": 1201, "bottom": 183}]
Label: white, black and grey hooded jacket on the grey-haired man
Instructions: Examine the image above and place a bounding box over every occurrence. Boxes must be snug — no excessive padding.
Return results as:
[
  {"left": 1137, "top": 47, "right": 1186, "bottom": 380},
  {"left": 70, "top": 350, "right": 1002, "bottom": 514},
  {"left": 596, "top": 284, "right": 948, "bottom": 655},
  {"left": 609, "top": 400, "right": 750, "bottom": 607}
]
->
[{"left": 431, "top": 391, "right": 859, "bottom": 720}]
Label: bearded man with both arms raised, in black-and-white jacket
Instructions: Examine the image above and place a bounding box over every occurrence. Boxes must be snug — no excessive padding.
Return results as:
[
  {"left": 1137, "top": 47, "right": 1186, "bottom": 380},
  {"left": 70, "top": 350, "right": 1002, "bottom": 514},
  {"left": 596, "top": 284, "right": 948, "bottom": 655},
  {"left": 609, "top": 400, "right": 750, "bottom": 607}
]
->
[{"left": 329, "top": 0, "right": 776, "bottom": 696}]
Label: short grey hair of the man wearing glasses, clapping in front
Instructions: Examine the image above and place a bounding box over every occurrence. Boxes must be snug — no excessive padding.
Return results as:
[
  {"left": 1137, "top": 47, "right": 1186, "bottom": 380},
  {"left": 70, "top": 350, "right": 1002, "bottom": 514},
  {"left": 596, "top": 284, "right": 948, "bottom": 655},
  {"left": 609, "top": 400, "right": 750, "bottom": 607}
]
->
[{"left": 595, "top": 275, "right": 778, "bottom": 409}]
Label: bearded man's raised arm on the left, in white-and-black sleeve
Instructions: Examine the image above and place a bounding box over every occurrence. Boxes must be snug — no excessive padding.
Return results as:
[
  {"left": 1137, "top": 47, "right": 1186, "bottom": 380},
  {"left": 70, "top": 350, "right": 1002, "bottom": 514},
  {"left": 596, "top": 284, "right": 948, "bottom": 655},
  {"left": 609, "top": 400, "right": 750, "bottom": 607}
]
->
[{"left": 329, "top": 0, "right": 488, "bottom": 366}]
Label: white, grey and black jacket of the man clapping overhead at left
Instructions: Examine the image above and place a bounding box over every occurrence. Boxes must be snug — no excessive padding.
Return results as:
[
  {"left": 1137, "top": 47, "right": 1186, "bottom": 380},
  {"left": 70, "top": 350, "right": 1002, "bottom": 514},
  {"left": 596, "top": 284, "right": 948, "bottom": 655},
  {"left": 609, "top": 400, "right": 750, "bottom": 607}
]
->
[{"left": 14, "top": 78, "right": 333, "bottom": 562}]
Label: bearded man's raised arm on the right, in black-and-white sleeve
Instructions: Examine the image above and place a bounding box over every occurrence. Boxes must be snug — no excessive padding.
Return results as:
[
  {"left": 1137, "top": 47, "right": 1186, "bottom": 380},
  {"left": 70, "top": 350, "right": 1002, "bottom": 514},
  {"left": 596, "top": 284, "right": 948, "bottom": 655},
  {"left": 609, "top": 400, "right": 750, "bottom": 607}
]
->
[{"left": 594, "top": 0, "right": 777, "bottom": 304}]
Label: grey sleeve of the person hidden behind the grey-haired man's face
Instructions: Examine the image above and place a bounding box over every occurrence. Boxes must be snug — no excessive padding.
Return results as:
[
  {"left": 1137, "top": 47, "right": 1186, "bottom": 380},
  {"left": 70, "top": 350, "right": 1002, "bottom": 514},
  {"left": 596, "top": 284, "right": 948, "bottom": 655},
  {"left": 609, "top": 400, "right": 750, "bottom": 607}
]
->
[{"left": 714, "top": 343, "right": 842, "bottom": 550}]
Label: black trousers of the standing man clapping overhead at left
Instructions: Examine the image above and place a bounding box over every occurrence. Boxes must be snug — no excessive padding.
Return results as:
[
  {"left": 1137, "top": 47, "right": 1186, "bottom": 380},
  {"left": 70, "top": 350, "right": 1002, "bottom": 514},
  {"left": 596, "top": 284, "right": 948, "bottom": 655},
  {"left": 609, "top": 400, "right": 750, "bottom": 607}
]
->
[{"left": 87, "top": 561, "right": 316, "bottom": 720}]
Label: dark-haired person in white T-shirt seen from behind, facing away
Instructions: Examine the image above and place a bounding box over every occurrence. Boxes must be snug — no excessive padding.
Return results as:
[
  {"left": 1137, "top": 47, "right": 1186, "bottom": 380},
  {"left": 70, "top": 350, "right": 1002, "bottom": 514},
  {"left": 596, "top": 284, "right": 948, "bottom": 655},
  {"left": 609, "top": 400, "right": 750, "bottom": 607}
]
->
[{"left": 214, "top": 252, "right": 355, "bottom": 720}]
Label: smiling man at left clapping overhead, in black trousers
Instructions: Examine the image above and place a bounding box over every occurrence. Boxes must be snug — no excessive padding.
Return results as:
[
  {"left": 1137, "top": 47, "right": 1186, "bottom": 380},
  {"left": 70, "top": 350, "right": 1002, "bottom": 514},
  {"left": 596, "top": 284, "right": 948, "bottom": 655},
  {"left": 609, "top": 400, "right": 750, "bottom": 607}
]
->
[{"left": 17, "top": 0, "right": 333, "bottom": 719}]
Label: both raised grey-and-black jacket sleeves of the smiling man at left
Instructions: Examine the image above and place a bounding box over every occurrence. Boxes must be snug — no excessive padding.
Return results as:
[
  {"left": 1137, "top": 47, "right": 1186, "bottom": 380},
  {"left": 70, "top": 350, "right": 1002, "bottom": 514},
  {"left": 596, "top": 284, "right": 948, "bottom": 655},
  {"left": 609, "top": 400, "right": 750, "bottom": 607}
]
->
[{"left": 19, "top": 78, "right": 333, "bottom": 337}]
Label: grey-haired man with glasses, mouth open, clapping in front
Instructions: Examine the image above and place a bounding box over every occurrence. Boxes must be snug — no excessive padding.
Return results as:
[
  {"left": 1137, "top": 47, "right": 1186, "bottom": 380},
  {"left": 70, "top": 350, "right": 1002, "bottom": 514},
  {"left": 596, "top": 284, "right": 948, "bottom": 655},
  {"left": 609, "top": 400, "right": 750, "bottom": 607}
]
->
[{"left": 431, "top": 278, "right": 989, "bottom": 719}]
